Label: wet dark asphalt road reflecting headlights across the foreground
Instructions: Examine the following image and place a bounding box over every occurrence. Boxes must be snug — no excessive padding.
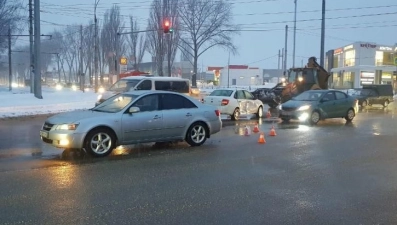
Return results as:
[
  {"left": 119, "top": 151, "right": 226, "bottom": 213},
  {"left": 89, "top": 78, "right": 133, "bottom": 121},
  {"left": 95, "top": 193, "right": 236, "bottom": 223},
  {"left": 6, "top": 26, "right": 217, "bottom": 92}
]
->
[{"left": 0, "top": 105, "right": 397, "bottom": 224}]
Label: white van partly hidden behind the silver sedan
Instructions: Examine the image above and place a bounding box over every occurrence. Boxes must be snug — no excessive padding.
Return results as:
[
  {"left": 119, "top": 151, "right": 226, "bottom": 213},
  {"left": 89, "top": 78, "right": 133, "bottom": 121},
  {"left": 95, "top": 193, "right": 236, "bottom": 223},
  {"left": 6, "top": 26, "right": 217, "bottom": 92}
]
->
[{"left": 96, "top": 76, "right": 191, "bottom": 105}]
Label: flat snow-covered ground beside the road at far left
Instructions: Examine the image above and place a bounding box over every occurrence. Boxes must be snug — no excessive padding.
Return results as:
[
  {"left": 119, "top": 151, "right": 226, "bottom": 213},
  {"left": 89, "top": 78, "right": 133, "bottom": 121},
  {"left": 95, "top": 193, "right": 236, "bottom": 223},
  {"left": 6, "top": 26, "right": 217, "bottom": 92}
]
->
[{"left": 0, "top": 86, "right": 97, "bottom": 118}]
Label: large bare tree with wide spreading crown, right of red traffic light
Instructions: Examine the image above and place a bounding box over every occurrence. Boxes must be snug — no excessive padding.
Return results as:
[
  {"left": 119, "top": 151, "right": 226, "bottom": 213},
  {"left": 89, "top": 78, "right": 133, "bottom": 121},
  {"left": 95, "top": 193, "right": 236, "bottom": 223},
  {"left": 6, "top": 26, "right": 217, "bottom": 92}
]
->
[{"left": 179, "top": 0, "right": 238, "bottom": 86}]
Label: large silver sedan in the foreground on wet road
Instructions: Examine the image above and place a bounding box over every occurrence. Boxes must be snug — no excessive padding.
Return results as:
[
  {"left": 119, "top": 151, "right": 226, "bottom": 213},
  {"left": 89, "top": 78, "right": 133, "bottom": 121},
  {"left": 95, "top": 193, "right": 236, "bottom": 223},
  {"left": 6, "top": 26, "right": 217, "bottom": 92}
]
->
[{"left": 40, "top": 91, "right": 222, "bottom": 156}]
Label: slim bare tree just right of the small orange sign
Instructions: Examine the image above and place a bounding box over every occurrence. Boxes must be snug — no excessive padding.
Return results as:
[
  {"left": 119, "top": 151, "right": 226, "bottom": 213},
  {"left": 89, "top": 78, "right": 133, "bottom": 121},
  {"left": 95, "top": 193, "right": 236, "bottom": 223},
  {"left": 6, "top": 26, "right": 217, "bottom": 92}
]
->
[{"left": 127, "top": 16, "right": 147, "bottom": 70}]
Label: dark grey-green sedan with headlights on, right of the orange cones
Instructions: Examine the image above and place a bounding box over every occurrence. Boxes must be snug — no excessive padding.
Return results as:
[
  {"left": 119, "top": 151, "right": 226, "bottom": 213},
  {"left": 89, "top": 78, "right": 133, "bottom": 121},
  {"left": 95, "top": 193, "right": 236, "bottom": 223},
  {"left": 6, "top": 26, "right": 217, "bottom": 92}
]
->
[{"left": 279, "top": 90, "right": 358, "bottom": 124}]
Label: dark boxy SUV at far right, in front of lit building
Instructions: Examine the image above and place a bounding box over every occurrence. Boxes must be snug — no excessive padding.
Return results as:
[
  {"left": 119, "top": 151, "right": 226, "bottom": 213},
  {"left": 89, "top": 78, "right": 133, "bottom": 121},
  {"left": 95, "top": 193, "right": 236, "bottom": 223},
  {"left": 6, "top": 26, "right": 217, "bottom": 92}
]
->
[{"left": 350, "top": 84, "right": 394, "bottom": 107}]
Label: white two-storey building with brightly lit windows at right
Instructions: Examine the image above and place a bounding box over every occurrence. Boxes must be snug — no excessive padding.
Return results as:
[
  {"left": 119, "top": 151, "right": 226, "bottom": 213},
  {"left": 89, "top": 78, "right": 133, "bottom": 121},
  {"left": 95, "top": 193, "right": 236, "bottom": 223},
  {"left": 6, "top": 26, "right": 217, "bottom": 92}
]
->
[{"left": 325, "top": 42, "right": 397, "bottom": 89}]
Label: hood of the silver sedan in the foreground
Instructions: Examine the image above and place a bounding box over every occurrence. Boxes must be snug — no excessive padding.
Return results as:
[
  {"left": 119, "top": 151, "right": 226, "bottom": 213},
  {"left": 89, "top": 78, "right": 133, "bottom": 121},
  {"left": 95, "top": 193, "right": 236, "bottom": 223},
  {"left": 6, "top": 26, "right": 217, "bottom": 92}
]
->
[{"left": 47, "top": 110, "right": 109, "bottom": 124}]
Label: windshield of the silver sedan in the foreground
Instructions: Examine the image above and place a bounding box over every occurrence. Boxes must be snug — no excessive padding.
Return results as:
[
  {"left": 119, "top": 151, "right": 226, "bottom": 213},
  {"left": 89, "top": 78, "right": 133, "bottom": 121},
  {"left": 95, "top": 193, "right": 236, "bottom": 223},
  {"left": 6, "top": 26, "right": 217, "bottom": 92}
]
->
[{"left": 91, "top": 94, "right": 138, "bottom": 113}]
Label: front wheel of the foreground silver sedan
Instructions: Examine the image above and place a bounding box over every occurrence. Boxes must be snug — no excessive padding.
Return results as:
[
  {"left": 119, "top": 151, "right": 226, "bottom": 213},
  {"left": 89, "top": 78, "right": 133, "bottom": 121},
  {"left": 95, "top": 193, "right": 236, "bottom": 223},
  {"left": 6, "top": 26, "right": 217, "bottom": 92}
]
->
[{"left": 84, "top": 128, "right": 116, "bottom": 157}]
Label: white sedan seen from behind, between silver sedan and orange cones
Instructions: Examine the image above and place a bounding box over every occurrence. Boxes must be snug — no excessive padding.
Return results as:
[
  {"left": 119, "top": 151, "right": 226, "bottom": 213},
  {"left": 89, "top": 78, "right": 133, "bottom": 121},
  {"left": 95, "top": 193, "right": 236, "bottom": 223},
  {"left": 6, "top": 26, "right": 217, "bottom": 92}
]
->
[{"left": 203, "top": 88, "right": 263, "bottom": 120}]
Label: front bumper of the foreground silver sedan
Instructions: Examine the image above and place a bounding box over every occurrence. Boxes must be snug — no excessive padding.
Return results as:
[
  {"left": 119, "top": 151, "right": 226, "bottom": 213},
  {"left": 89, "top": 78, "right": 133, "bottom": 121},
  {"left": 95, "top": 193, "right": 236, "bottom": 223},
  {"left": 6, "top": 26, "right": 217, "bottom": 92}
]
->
[{"left": 40, "top": 130, "right": 86, "bottom": 149}]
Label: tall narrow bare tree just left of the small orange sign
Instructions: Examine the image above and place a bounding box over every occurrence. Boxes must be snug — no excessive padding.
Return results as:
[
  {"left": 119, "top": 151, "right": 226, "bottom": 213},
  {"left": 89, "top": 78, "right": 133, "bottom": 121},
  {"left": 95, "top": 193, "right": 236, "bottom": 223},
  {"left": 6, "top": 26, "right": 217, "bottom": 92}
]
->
[{"left": 101, "top": 5, "right": 125, "bottom": 83}]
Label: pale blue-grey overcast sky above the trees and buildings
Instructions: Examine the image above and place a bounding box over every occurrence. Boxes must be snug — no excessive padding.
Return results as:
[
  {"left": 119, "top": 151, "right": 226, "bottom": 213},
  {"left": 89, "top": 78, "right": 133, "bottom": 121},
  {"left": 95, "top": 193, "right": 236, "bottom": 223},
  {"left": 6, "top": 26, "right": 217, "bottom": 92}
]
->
[{"left": 14, "top": 0, "right": 397, "bottom": 69}]
